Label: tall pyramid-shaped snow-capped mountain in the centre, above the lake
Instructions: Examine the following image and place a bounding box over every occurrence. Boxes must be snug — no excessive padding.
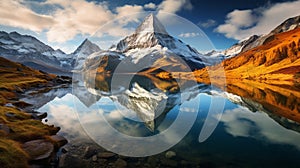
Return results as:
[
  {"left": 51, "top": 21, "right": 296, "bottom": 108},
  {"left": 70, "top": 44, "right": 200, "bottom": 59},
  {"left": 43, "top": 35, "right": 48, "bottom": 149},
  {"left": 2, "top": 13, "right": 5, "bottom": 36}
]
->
[{"left": 85, "top": 14, "right": 205, "bottom": 72}]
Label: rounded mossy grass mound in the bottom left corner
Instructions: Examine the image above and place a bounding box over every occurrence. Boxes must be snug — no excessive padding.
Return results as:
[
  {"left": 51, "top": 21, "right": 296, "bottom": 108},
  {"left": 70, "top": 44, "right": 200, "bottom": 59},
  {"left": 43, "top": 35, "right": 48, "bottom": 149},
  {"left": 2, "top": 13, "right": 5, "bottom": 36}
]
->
[{"left": 0, "top": 138, "right": 29, "bottom": 168}]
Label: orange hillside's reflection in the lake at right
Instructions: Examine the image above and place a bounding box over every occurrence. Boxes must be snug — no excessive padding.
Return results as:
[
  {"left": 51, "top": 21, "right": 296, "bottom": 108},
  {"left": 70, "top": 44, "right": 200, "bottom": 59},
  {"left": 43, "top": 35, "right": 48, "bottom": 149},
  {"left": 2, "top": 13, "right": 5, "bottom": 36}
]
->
[{"left": 226, "top": 80, "right": 300, "bottom": 123}]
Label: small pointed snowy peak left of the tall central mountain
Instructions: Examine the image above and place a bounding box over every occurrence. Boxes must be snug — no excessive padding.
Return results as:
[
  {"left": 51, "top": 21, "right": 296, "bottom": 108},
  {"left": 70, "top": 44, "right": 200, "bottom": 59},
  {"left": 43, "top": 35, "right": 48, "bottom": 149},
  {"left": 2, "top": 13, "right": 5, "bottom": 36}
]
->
[{"left": 72, "top": 39, "right": 101, "bottom": 70}]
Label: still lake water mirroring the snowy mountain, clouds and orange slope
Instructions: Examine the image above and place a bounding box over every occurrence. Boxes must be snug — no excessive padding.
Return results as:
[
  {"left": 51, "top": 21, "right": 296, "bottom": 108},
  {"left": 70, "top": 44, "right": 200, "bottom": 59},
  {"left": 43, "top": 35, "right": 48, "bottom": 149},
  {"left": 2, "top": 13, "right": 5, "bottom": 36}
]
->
[{"left": 27, "top": 75, "right": 300, "bottom": 167}]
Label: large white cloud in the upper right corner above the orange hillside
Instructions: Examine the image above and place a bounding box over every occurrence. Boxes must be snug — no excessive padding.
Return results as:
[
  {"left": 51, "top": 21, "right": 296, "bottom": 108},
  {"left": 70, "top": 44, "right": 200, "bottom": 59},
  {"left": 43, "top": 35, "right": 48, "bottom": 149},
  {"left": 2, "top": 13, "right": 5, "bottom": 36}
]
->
[{"left": 215, "top": 0, "right": 300, "bottom": 40}]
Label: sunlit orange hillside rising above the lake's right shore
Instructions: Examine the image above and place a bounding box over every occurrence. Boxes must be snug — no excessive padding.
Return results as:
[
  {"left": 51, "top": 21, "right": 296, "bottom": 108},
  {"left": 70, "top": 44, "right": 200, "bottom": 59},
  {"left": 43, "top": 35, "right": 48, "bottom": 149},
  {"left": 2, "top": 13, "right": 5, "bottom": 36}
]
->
[{"left": 194, "top": 28, "right": 300, "bottom": 85}]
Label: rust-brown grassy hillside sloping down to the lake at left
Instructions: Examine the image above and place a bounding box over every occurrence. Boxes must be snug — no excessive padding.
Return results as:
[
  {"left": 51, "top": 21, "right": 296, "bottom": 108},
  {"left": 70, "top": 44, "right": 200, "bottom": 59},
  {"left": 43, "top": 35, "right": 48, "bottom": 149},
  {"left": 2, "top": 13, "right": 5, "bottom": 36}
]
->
[{"left": 0, "top": 57, "right": 68, "bottom": 167}]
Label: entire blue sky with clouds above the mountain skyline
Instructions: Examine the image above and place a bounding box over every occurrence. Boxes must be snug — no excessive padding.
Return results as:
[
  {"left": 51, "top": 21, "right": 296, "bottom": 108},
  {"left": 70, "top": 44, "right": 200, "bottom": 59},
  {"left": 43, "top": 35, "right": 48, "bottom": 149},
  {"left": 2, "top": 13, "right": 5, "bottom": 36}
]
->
[{"left": 0, "top": 0, "right": 300, "bottom": 53}]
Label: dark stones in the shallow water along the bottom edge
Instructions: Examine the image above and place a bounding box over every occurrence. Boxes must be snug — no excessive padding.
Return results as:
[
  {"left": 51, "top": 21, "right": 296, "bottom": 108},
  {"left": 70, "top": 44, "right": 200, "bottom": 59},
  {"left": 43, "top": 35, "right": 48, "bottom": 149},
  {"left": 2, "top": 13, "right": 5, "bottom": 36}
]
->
[{"left": 58, "top": 140, "right": 200, "bottom": 168}]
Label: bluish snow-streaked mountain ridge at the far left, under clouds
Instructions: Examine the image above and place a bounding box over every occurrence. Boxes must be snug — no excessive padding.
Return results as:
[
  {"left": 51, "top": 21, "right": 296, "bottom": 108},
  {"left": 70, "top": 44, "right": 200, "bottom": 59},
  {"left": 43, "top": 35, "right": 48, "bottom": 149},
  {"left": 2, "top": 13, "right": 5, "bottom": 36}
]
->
[{"left": 0, "top": 31, "right": 73, "bottom": 73}]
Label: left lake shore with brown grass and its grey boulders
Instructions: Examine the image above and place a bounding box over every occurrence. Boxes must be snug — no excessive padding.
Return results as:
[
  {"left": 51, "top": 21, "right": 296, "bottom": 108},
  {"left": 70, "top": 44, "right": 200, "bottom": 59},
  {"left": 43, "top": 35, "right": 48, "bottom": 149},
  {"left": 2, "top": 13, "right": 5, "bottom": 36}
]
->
[{"left": 0, "top": 58, "right": 72, "bottom": 167}]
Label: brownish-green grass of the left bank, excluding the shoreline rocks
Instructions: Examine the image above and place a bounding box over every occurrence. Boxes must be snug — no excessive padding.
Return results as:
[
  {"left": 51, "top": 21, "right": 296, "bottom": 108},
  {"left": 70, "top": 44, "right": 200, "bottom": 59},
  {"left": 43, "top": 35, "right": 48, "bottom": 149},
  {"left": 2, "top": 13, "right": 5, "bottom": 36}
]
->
[{"left": 0, "top": 57, "right": 58, "bottom": 167}]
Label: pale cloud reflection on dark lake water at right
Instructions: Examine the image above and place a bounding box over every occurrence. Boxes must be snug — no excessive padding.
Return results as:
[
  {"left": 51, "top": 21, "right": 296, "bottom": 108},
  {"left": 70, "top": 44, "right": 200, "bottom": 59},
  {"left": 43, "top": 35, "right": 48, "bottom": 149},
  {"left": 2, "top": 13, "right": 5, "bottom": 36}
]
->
[{"left": 221, "top": 107, "right": 300, "bottom": 149}]
